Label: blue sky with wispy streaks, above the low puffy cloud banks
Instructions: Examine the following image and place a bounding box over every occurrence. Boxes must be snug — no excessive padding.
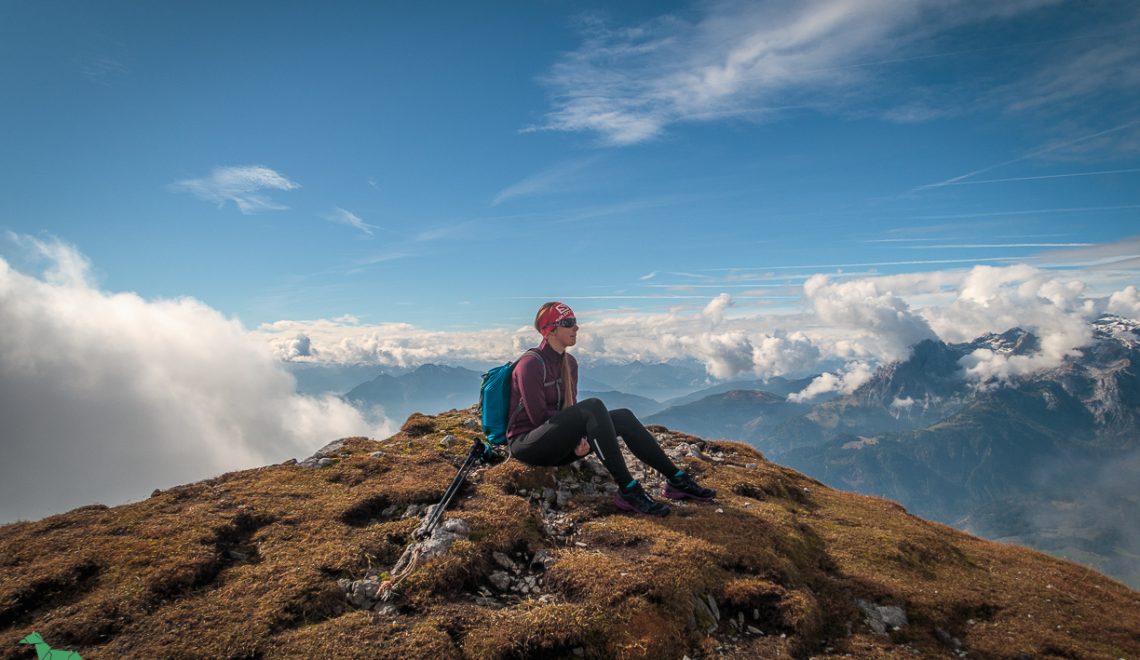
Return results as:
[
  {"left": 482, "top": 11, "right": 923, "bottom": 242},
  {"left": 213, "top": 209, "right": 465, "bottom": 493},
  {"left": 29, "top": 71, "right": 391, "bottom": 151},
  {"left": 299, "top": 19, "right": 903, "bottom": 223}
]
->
[{"left": 0, "top": 2, "right": 1140, "bottom": 331}]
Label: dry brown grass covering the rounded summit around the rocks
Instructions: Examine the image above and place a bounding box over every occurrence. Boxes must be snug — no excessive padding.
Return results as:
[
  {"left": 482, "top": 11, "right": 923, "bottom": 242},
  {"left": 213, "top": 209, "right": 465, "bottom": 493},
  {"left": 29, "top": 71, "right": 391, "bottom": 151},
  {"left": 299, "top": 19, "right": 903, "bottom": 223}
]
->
[{"left": 0, "top": 412, "right": 1140, "bottom": 659}]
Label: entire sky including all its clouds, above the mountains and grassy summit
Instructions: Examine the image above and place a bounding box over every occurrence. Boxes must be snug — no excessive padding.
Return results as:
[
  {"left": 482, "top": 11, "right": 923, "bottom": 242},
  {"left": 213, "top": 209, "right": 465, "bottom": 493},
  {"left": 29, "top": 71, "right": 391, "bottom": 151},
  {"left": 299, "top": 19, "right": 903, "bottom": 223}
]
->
[{"left": 0, "top": 0, "right": 1140, "bottom": 522}]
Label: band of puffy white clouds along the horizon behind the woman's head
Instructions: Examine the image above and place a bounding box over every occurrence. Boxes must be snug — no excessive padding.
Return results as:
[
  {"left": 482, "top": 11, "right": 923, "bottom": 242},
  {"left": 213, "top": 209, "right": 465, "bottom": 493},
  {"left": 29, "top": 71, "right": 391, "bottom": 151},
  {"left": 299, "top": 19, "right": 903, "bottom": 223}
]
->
[{"left": 257, "top": 256, "right": 1140, "bottom": 400}]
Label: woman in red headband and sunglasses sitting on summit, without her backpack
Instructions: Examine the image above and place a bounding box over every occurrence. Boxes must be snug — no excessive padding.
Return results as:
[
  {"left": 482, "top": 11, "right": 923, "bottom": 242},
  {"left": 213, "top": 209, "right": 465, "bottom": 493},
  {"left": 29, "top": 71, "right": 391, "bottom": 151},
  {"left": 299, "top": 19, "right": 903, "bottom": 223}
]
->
[{"left": 506, "top": 302, "right": 716, "bottom": 515}]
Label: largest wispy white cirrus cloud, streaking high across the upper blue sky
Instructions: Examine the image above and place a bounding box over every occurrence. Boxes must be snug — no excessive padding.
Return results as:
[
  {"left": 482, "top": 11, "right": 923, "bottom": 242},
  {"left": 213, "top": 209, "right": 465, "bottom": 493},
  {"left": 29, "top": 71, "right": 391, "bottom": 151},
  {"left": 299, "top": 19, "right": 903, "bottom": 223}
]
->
[{"left": 528, "top": 0, "right": 1056, "bottom": 145}]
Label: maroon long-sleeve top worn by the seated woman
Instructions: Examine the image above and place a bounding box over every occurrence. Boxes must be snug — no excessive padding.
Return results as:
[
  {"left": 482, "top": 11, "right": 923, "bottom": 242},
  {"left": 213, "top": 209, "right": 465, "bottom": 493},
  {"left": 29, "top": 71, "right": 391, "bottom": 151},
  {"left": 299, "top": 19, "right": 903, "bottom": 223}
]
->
[{"left": 506, "top": 340, "right": 578, "bottom": 438}]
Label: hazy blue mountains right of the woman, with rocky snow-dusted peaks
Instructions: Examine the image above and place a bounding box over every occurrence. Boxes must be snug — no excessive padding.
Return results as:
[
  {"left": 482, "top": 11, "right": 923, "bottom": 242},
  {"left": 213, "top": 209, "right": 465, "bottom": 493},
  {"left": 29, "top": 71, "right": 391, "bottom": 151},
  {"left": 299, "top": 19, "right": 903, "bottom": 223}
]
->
[{"left": 649, "top": 317, "right": 1140, "bottom": 586}]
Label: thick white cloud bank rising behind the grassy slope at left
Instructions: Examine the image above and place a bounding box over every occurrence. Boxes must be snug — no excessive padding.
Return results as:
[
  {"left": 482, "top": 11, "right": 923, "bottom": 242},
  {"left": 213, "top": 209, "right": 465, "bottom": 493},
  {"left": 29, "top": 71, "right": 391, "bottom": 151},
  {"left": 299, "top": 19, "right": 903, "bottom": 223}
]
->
[{"left": 0, "top": 238, "right": 391, "bottom": 523}]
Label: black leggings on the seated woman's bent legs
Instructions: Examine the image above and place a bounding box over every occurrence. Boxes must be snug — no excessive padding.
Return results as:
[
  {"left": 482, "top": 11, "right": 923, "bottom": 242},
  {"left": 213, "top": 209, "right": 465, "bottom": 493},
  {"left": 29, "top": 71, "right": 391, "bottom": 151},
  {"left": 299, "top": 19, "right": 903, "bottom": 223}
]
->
[{"left": 511, "top": 399, "right": 677, "bottom": 488}]
